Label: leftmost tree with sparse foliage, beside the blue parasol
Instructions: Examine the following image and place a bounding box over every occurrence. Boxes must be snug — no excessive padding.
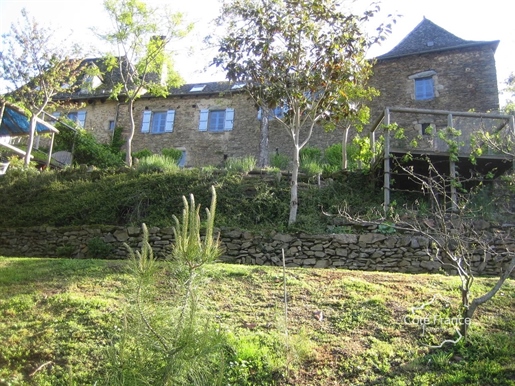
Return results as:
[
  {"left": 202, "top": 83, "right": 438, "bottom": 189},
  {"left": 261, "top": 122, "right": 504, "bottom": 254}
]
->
[{"left": 0, "top": 9, "right": 81, "bottom": 166}]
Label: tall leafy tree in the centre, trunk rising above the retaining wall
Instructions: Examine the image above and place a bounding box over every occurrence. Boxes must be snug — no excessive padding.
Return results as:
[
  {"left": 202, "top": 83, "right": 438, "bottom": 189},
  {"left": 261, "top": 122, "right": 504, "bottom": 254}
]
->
[{"left": 213, "top": 0, "right": 392, "bottom": 224}]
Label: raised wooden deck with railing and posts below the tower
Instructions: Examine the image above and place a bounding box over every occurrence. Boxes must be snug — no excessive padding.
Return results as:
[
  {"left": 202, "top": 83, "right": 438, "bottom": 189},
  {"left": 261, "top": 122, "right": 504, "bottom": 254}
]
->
[{"left": 370, "top": 107, "right": 515, "bottom": 208}]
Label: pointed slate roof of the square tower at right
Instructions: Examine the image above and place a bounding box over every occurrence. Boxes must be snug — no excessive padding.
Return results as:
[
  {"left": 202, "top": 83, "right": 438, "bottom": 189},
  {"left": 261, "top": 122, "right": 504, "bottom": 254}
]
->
[{"left": 376, "top": 18, "right": 499, "bottom": 60}]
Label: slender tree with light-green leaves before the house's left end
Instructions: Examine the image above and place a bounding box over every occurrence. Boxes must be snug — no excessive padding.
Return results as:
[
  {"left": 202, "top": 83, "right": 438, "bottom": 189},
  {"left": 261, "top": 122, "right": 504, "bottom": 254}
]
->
[{"left": 101, "top": 0, "right": 192, "bottom": 166}]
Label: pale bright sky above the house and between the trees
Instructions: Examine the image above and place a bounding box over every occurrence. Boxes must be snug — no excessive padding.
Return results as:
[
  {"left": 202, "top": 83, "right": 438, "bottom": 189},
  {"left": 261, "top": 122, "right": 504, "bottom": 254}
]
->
[{"left": 0, "top": 0, "right": 515, "bottom": 104}]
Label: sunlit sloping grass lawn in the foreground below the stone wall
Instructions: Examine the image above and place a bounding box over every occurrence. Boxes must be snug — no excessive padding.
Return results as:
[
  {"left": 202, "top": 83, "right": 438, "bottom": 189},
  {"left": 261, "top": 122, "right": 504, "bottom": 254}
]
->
[{"left": 0, "top": 257, "right": 515, "bottom": 386}]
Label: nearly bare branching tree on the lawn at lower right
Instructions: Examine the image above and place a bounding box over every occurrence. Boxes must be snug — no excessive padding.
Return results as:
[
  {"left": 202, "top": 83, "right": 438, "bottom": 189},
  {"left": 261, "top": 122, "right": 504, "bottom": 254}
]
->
[{"left": 342, "top": 154, "right": 515, "bottom": 337}]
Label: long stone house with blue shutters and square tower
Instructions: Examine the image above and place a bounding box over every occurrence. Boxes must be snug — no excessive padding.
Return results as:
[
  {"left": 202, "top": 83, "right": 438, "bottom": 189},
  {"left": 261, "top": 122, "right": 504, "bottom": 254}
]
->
[{"left": 50, "top": 19, "right": 510, "bottom": 166}]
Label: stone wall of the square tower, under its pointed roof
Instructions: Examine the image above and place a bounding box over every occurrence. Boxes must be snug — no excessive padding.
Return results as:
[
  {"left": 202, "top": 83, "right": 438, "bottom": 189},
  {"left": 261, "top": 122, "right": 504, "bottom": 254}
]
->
[{"left": 369, "top": 46, "right": 499, "bottom": 148}]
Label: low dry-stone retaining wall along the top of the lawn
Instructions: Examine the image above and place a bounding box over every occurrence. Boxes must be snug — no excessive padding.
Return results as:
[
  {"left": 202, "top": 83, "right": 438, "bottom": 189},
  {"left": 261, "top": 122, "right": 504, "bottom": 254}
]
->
[{"left": 0, "top": 226, "right": 515, "bottom": 276}]
